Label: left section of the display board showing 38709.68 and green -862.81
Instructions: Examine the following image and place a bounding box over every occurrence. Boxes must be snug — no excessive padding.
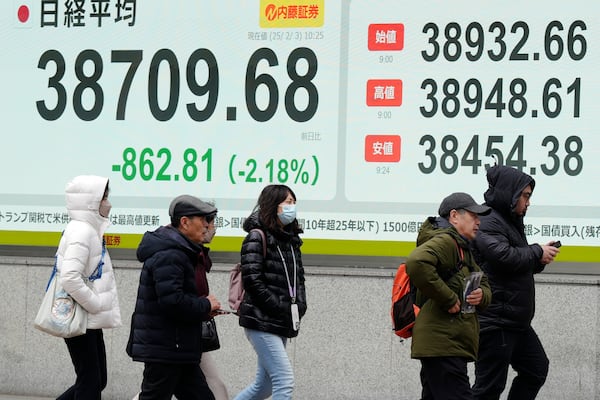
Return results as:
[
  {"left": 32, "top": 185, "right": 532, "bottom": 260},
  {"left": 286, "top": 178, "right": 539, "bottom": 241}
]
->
[{"left": 3, "top": 0, "right": 340, "bottom": 200}]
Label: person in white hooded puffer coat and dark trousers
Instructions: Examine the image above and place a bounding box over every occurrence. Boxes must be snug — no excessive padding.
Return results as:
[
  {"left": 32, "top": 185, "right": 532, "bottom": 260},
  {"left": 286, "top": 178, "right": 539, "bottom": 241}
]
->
[{"left": 56, "top": 175, "right": 121, "bottom": 400}]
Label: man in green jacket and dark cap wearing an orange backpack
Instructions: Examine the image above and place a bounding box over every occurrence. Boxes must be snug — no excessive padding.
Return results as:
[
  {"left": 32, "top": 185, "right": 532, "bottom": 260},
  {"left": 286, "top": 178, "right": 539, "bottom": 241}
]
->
[{"left": 406, "top": 192, "right": 492, "bottom": 400}]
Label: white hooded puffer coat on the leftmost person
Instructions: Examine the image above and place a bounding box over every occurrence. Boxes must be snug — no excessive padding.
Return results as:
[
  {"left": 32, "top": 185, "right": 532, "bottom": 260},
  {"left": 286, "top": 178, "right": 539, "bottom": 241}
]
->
[{"left": 56, "top": 175, "right": 121, "bottom": 329}]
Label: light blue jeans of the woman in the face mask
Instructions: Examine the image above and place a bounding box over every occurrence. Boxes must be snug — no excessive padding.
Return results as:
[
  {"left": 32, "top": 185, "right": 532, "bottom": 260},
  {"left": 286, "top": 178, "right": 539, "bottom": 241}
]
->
[{"left": 234, "top": 328, "right": 294, "bottom": 400}]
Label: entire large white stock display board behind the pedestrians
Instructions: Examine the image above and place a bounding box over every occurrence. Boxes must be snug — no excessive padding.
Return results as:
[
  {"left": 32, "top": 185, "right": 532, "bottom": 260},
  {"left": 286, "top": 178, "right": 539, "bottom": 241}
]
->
[{"left": 0, "top": 0, "right": 600, "bottom": 252}]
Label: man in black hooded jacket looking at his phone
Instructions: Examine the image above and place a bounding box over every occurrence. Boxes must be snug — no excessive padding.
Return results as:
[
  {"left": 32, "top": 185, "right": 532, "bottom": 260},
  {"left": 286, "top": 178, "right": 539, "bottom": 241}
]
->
[{"left": 473, "top": 166, "right": 558, "bottom": 400}]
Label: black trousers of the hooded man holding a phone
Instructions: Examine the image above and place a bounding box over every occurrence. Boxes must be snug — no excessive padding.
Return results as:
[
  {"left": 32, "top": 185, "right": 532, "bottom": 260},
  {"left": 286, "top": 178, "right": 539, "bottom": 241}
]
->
[{"left": 473, "top": 327, "right": 549, "bottom": 400}]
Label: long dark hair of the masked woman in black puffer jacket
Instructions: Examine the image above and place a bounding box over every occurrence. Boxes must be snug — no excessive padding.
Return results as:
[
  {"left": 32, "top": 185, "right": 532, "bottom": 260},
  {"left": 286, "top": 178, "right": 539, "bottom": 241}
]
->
[{"left": 256, "top": 185, "right": 304, "bottom": 234}]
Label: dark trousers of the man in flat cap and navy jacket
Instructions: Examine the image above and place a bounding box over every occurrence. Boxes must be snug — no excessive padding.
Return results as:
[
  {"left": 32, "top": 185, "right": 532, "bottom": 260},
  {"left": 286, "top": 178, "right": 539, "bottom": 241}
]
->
[{"left": 139, "top": 362, "right": 215, "bottom": 400}]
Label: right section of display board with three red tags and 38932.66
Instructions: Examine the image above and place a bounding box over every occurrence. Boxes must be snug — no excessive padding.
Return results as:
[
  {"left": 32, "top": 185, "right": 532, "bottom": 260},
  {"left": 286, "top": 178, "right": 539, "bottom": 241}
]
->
[{"left": 346, "top": 0, "right": 600, "bottom": 207}]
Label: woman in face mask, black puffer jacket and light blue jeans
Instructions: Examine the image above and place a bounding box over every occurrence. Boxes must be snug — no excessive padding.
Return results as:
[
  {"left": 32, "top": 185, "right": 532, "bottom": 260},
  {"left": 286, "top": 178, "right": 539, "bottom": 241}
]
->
[{"left": 235, "top": 185, "right": 306, "bottom": 400}]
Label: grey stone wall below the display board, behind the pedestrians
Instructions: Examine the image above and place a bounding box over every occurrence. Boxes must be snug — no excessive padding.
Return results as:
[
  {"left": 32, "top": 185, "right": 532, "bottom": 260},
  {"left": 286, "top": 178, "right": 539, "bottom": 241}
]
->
[{"left": 0, "top": 257, "right": 600, "bottom": 400}]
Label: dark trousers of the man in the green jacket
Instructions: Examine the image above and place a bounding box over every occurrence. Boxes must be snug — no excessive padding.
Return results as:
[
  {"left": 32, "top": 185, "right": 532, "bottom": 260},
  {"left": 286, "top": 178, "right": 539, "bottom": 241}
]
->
[{"left": 421, "top": 357, "right": 473, "bottom": 400}]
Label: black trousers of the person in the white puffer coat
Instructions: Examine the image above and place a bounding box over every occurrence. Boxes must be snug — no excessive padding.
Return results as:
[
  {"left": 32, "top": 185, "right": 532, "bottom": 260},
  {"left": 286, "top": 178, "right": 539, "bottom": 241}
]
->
[{"left": 56, "top": 329, "right": 107, "bottom": 400}]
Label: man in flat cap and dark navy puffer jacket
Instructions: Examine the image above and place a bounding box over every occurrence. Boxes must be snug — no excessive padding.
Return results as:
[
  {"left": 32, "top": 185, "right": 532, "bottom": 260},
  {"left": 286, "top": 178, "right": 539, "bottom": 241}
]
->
[{"left": 127, "top": 195, "right": 221, "bottom": 400}]
